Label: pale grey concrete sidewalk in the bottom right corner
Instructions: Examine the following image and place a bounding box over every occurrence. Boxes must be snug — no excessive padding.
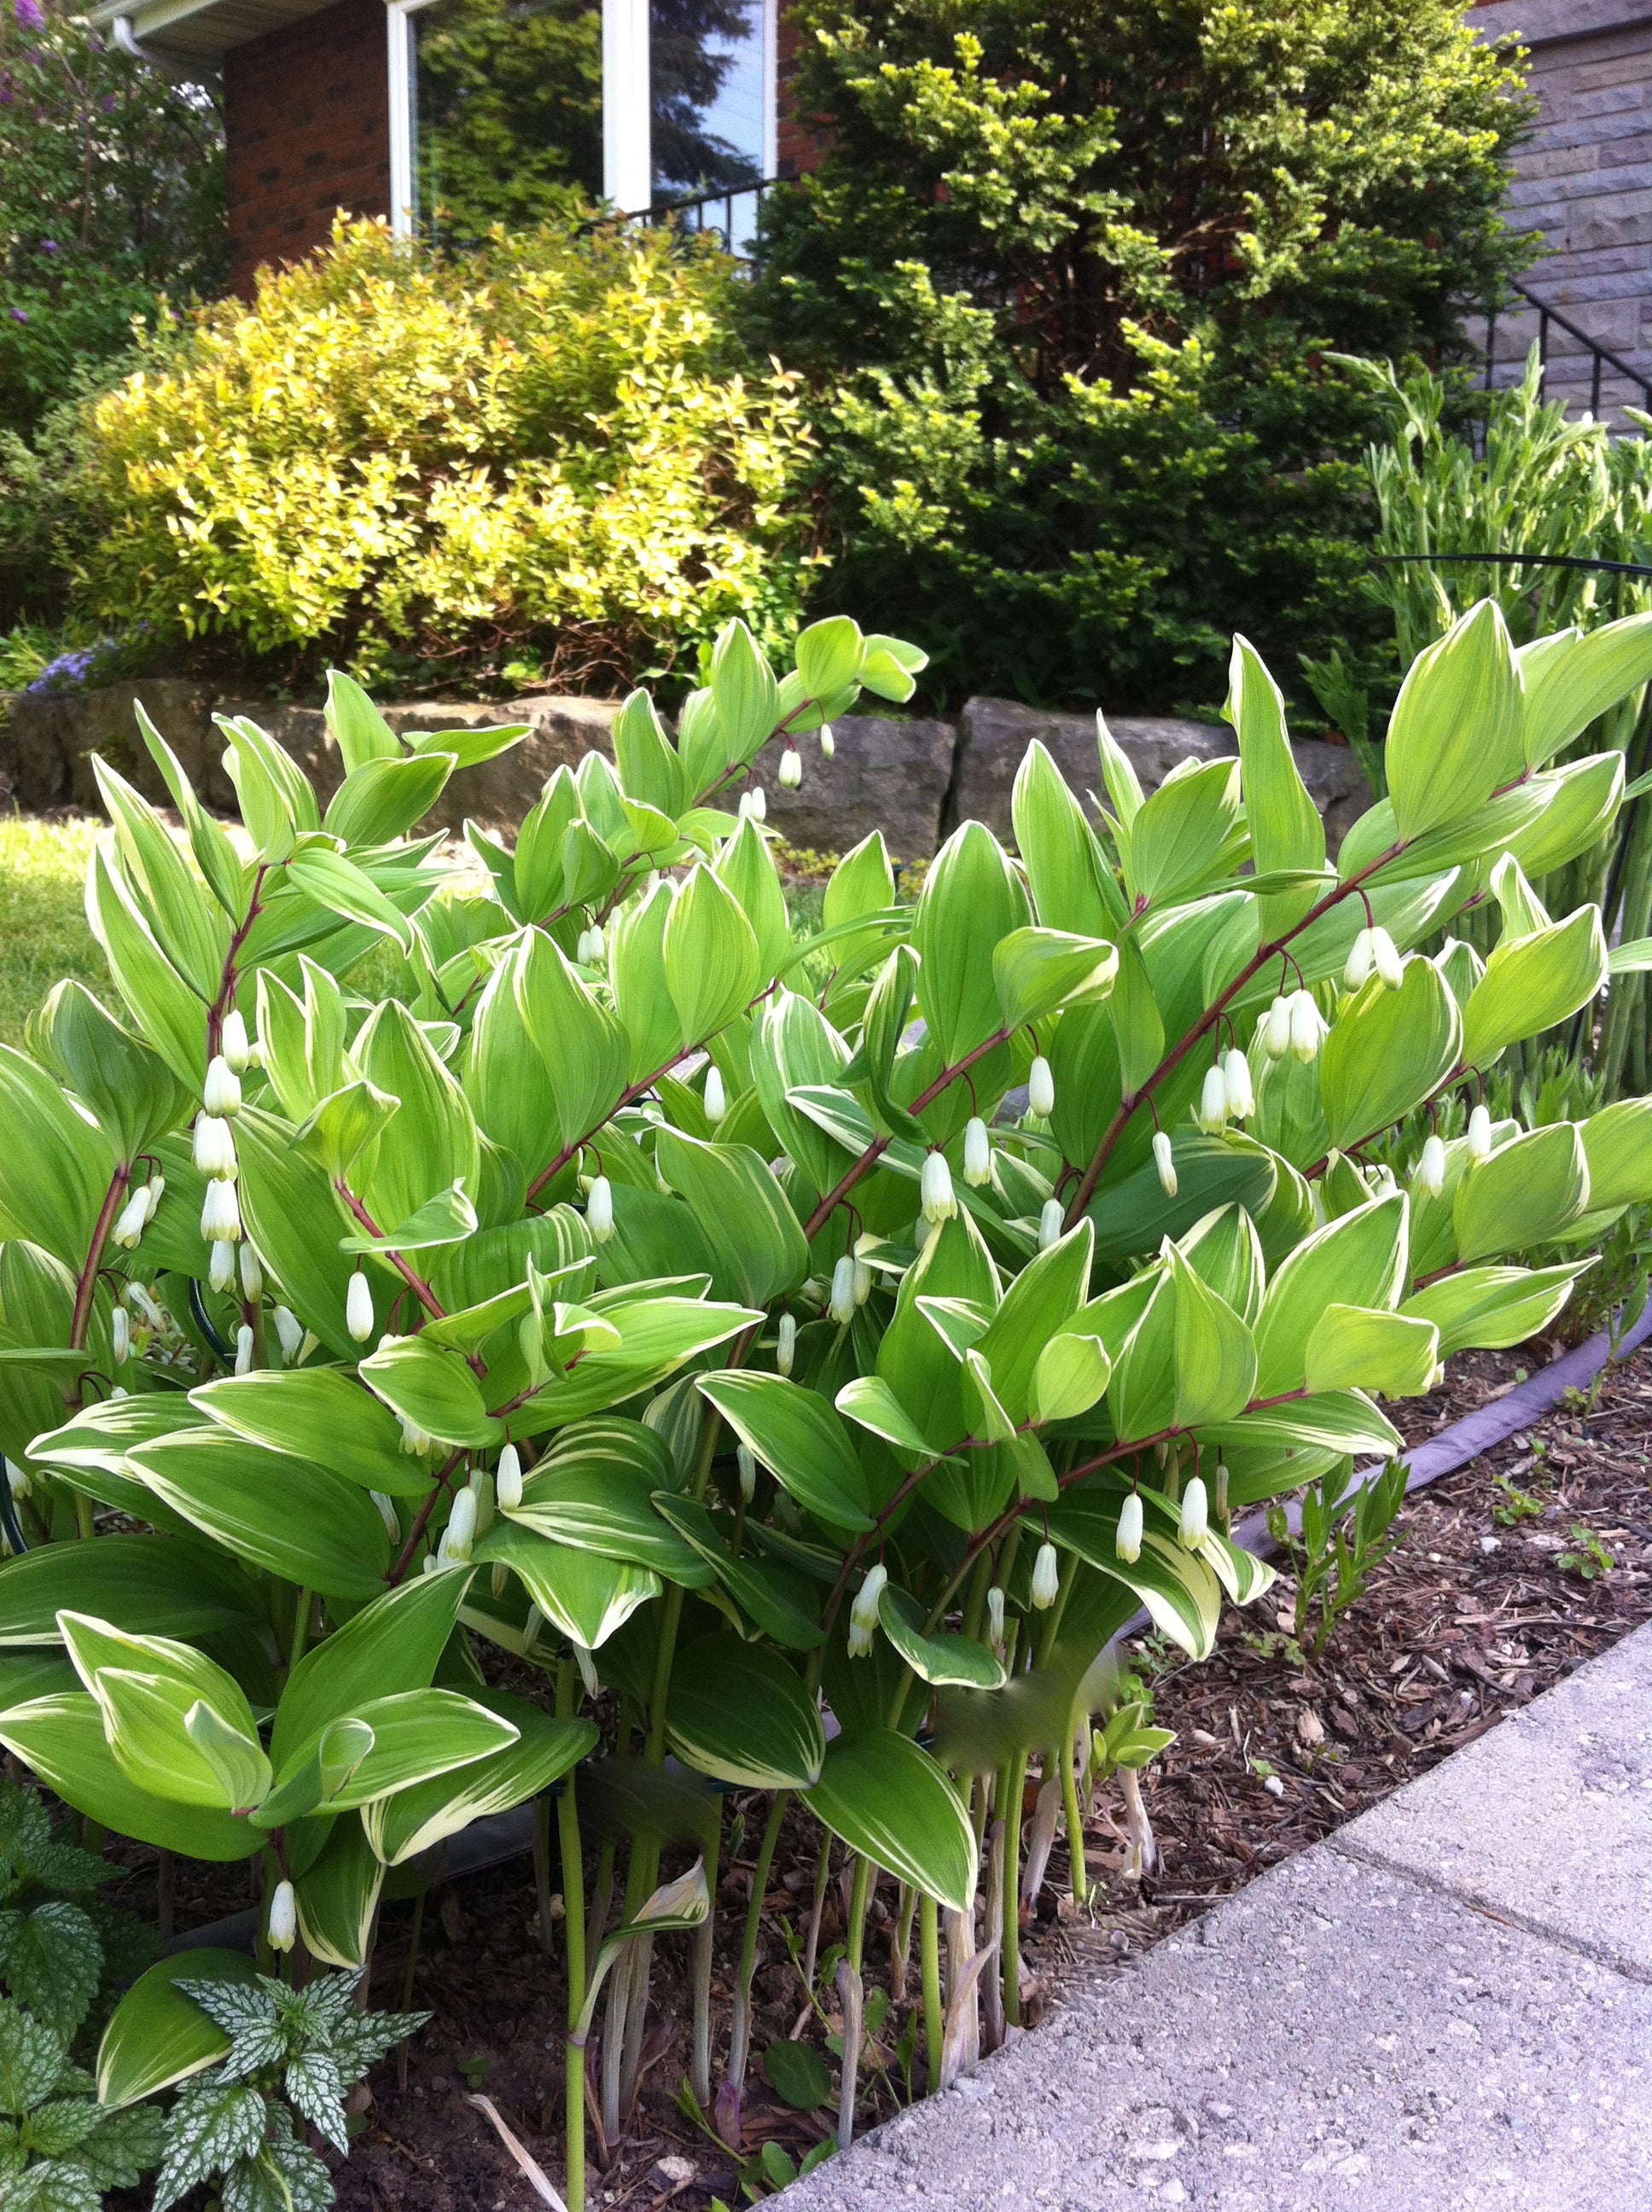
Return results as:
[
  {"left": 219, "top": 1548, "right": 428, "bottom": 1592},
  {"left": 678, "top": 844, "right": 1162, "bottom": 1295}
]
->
[{"left": 785, "top": 1628, "right": 1652, "bottom": 2212}]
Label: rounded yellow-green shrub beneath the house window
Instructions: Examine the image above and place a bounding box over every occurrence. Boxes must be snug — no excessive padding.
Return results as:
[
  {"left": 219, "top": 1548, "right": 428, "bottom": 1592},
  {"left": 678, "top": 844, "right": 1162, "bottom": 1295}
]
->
[{"left": 79, "top": 224, "right": 823, "bottom": 677}]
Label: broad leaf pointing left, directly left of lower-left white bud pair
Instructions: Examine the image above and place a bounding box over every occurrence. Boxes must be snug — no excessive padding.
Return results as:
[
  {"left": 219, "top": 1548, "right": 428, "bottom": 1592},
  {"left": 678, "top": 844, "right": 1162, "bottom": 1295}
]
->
[{"left": 126, "top": 1429, "right": 389, "bottom": 1597}]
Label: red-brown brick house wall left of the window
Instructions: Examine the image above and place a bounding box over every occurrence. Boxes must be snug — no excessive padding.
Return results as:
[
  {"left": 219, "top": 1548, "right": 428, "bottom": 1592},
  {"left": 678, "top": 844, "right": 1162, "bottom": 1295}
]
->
[{"left": 224, "top": 0, "right": 389, "bottom": 296}]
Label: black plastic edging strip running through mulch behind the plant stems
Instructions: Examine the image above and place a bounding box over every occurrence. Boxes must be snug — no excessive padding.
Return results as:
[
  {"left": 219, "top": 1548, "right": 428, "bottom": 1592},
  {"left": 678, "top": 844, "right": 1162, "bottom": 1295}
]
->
[{"left": 168, "top": 1301, "right": 1652, "bottom": 1951}]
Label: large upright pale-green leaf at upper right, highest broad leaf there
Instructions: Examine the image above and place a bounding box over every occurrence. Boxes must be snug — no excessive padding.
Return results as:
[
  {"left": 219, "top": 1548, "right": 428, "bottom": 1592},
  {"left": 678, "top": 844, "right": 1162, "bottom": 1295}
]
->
[{"left": 1384, "top": 599, "right": 1526, "bottom": 841}]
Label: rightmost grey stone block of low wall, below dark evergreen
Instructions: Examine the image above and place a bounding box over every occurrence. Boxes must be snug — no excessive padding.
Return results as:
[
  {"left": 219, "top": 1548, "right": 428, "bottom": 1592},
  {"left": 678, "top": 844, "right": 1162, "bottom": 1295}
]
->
[{"left": 946, "top": 699, "right": 1371, "bottom": 854}]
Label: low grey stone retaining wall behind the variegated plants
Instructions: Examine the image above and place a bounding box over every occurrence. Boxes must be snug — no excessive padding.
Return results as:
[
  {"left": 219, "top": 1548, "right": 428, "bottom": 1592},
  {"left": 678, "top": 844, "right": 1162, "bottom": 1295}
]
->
[{"left": 0, "top": 677, "right": 1371, "bottom": 860}]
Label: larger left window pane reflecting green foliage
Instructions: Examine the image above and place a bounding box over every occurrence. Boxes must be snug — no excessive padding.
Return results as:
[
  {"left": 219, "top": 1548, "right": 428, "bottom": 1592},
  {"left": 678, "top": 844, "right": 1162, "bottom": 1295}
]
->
[{"left": 409, "top": 0, "right": 602, "bottom": 242}]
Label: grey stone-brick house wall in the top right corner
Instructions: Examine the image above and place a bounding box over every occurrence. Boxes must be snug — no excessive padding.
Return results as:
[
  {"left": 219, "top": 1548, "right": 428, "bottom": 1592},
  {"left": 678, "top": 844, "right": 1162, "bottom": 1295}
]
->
[{"left": 1469, "top": 0, "right": 1652, "bottom": 414}]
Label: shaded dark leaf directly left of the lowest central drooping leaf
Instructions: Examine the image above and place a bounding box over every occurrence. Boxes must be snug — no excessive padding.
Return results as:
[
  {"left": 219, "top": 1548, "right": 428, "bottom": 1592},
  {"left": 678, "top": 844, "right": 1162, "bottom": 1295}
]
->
[{"left": 666, "top": 1634, "right": 825, "bottom": 1790}]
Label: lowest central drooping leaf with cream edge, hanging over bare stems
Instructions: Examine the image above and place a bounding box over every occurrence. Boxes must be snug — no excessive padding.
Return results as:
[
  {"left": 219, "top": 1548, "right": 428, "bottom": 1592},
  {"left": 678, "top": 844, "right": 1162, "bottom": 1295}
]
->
[{"left": 805, "top": 1727, "right": 980, "bottom": 1913}]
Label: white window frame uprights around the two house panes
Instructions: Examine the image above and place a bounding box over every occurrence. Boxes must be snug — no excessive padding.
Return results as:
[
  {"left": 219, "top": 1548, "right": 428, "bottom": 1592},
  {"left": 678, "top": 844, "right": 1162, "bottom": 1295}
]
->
[{"left": 385, "top": 0, "right": 781, "bottom": 239}]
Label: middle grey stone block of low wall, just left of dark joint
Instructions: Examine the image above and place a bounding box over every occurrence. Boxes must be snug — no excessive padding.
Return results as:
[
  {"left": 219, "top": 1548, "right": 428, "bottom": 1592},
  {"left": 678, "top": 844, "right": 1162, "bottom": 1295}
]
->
[{"left": 756, "top": 714, "right": 957, "bottom": 860}]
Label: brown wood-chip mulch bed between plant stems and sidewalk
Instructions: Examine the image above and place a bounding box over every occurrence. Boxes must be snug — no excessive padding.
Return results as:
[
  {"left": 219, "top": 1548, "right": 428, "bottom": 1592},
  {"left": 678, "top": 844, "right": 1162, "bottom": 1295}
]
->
[{"left": 90, "top": 1345, "right": 1652, "bottom": 2212}]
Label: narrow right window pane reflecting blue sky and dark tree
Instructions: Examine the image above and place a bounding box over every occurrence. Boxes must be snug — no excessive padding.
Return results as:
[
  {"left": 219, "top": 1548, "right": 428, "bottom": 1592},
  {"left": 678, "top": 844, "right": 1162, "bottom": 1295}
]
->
[{"left": 648, "top": 0, "right": 767, "bottom": 203}]
